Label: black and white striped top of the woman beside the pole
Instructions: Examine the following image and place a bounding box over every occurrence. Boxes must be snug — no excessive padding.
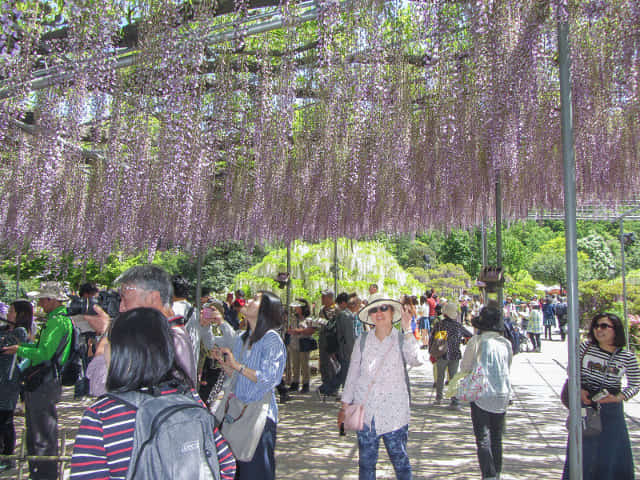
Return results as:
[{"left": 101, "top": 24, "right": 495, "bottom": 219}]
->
[{"left": 580, "top": 341, "right": 640, "bottom": 400}]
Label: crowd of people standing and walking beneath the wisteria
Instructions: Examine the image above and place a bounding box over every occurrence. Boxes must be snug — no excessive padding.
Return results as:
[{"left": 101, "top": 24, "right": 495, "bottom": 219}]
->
[{"left": 0, "top": 265, "right": 640, "bottom": 480}]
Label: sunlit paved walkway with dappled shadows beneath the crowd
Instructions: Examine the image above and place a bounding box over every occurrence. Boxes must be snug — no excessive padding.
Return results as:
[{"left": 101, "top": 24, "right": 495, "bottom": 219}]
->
[{"left": 0, "top": 341, "right": 640, "bottom": 480}]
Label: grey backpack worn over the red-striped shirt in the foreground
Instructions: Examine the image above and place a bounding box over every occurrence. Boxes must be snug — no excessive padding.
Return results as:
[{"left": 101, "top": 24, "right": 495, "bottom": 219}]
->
[{"left": 107, "top": 392, "right": 220, "bottom": 480}]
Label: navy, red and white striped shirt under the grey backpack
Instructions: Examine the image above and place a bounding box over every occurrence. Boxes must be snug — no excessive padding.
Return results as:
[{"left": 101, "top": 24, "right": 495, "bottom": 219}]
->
[{"left": 71, "top": 388, "right": 236, "bottom": 480}]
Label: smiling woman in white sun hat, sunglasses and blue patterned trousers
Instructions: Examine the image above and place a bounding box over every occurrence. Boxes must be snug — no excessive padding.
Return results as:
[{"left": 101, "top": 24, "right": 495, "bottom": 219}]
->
[{"left": 338, "top": 294, "right": 423, "bottom": 480}]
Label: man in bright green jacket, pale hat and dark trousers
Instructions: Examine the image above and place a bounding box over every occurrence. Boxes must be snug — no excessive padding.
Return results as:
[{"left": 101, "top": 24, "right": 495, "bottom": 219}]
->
[{"left": 2, "top": 282, "right": 72, "bottom": 480}]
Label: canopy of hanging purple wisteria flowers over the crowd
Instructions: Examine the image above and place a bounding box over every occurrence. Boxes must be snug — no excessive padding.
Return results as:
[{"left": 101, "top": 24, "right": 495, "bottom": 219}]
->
[{"left": 0, "top": 0, "right": 640, "bottom": 257}]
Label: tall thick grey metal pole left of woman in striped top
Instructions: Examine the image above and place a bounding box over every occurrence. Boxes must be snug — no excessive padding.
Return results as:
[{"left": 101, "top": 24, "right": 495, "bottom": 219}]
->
[{"left": 558, "top": 12, "right": 582, "bottom": 480}]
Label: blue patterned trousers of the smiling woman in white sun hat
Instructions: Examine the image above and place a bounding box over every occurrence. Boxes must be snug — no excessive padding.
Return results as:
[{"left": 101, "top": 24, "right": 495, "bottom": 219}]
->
[{"left": 358, "top": 420, "right": 411, "bottom": 480}]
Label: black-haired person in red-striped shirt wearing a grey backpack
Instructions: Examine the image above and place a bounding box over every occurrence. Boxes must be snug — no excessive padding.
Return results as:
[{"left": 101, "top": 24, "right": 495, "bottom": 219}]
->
[{"left": 71, "top": 308, "right": 236, "bottom": 480}]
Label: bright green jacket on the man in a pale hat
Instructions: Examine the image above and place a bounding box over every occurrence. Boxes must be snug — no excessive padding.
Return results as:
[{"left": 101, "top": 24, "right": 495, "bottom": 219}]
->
[{"left": 18, "top": 305, "right": 72, "bottom": 365}]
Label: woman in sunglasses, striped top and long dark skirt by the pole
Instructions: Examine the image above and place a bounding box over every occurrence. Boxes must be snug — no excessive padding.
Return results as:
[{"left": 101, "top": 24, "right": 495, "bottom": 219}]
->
[{"left": 562, "top": 313, "right": 640, "bottom": 480}]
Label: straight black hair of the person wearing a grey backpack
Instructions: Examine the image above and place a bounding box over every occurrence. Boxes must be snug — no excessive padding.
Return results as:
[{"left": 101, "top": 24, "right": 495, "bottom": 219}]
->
[{"left": 107, "top": 308, "right": 191, "bottom": 392}]
